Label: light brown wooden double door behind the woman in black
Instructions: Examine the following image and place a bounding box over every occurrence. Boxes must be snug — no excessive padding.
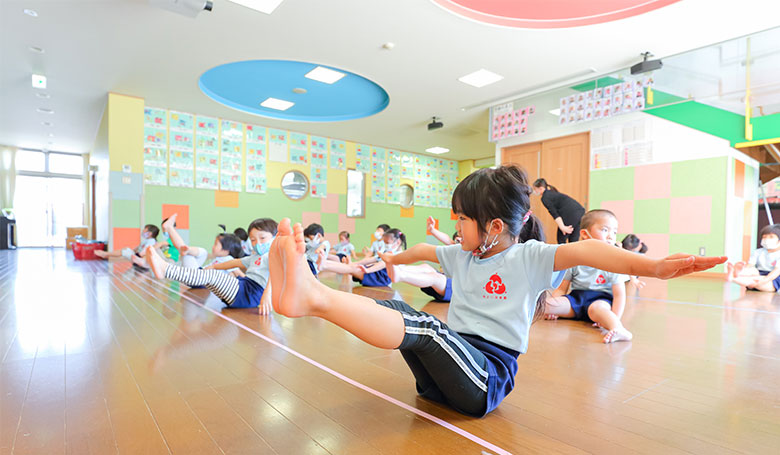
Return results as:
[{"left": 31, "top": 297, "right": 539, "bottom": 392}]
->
[{"left": 501, "top": 133, "right": 590, "bottom": 243}]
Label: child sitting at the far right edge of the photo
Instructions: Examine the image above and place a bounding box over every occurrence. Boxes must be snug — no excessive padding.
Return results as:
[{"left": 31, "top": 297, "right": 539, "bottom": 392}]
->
[{"left": 726, "top": 224, "right": 780, "bottom": 292}]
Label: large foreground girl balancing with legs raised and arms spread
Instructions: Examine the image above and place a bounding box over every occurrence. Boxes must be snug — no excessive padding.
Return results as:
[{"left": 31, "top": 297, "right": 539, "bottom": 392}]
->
[{"left": 269, "top": 166, "right": 726, "bottom": 416}]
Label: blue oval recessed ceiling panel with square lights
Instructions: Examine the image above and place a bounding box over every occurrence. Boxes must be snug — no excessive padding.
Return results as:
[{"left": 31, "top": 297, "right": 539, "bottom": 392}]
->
[{"left": 198, "top": 60, "right": 390, "bottom": 122}]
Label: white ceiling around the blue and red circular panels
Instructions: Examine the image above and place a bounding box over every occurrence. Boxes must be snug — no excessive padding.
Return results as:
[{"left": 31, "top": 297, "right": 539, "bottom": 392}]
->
[{"left": 0, "top": 0, "right": 780, "bottom": 160}]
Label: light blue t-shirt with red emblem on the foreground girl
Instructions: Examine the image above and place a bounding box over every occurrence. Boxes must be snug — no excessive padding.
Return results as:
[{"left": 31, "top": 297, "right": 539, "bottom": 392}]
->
[{"left": 436, "top": 240, "right": 558, "bottom": 353}]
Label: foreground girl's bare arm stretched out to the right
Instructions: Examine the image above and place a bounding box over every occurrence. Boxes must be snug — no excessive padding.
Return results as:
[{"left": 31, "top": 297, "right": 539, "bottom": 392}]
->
[{"left": 554, "top": 240, "right": 728, "bottom": 279}]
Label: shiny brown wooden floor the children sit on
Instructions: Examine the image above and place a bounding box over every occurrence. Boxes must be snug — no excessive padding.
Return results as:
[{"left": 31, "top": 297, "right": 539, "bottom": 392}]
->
[{"left": 0, "top": 249, "right": 780, "bottom": 455}]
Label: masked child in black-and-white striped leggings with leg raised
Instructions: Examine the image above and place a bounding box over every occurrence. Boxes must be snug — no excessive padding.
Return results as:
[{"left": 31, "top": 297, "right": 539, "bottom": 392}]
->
[{"left": 146, "top": 218, "right": 277, "bottom": 314}]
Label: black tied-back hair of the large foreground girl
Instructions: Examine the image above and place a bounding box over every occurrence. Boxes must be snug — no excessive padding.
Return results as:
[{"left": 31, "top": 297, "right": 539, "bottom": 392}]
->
[{"left": 452, "top": 165, "right": 544, "bottom": 243}]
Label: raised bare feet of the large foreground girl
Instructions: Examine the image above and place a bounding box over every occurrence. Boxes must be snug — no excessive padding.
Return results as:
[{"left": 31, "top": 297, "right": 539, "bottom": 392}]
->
[{"left": 268, "top": 218, "right": 326, "bottom": 318}]
